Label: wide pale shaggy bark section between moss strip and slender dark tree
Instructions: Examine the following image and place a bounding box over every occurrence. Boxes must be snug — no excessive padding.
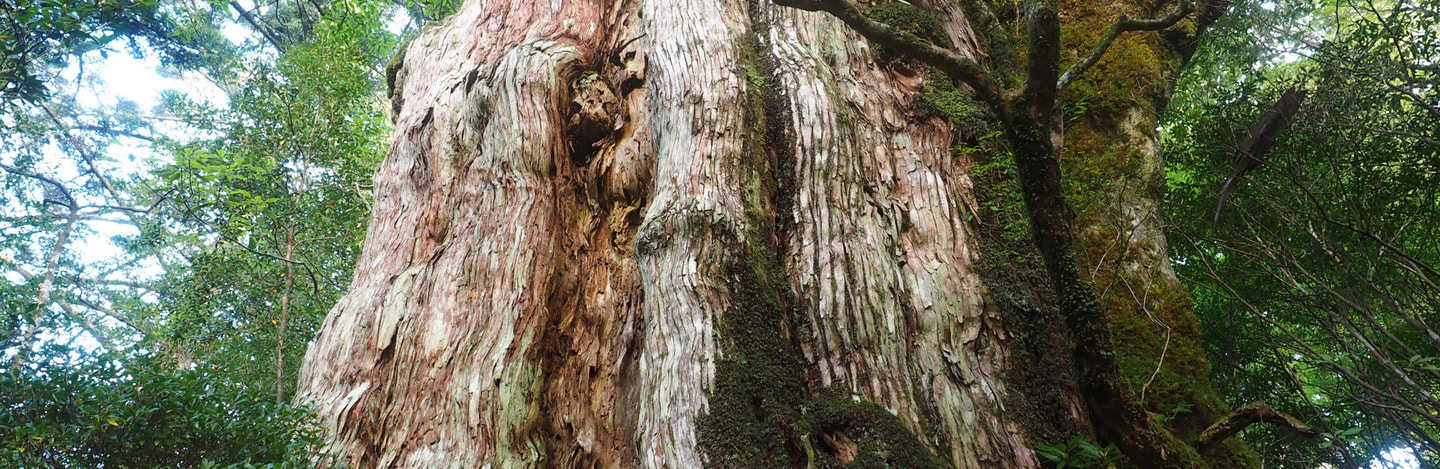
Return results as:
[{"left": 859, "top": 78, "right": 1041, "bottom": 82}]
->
[{"left": 770, "top": 9, "right": 1038, "bottom": 468}]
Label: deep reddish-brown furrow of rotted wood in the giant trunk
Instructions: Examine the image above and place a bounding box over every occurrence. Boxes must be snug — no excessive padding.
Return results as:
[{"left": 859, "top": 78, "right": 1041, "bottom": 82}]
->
[{"left": 540, "top": 12, "right": 654, "bottom": 468}]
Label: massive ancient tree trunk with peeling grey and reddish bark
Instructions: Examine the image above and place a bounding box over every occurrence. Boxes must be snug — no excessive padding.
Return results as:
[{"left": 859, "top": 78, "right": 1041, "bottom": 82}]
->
[{"left": 300, "top": 0, "right": 1243, "bottom": 468}]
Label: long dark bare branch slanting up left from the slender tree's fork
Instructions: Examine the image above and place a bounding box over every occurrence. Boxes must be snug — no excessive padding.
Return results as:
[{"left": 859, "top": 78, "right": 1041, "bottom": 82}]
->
[{"left": 773, "top": 0, "right": 1004, "bottom": 112}]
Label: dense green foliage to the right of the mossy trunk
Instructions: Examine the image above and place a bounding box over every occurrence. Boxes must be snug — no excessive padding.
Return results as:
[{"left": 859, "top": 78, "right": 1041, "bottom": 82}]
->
[{"left": 1165, "top": 1, "right": 1440, "bottom": 468}]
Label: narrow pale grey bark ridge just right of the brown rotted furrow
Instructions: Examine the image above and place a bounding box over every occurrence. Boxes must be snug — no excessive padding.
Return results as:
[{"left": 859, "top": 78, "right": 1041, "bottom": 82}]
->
[{"left": 635, "top": 0, "right": 753, "bottom": 468}]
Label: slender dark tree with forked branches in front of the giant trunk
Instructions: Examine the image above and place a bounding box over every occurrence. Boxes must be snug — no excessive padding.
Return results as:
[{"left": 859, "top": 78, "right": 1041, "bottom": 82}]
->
[{"left": 775, "top": 0, "right": 1243, "bottom": 468}]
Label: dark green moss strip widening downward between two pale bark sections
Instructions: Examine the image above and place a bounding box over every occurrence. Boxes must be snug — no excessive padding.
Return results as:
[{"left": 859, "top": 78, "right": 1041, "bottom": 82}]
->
[{"left": 697, "top": 10, "right": 809, "bottom": 468}]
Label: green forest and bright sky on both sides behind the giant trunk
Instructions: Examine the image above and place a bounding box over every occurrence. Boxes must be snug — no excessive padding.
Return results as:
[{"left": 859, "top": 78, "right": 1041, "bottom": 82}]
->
[{"left": 0, "top": 0, "right": 1440, "bottom": 468}]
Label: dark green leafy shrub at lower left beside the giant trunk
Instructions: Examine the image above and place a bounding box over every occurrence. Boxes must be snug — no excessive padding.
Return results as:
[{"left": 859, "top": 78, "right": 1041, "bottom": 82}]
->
[{"left": 0, "top": 355, "right": 329, "bottom": 468}]
